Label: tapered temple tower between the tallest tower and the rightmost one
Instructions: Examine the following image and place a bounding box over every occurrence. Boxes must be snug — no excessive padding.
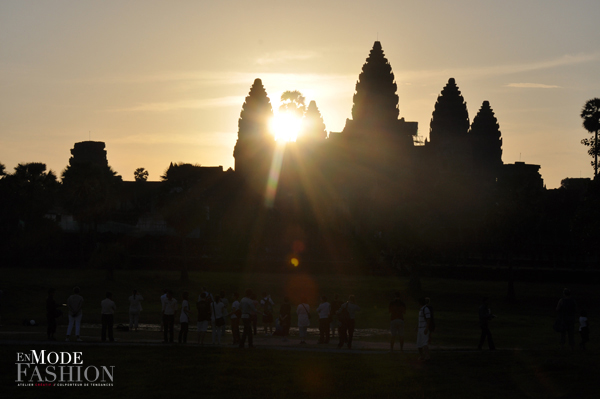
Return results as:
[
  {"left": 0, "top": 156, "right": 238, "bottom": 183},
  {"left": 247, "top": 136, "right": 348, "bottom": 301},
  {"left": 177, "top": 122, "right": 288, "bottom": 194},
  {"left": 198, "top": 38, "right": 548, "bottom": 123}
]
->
[{"left": 429, "top": 78, "right": 469, "bottom": 142}]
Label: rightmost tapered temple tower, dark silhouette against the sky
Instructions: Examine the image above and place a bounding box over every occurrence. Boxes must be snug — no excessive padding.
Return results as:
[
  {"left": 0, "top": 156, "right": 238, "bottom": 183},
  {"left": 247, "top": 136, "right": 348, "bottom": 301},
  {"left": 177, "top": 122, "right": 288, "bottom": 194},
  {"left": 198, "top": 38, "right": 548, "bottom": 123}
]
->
[{"left": 470, "top": 101, "right": 502, "bottom": 169}]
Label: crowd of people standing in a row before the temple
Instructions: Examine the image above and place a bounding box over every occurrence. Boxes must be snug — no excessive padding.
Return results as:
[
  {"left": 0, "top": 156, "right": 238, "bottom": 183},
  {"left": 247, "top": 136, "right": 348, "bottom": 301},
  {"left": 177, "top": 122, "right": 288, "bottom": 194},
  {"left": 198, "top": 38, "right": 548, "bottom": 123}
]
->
[{"left": 46, "top": 287, "right": 589, "bottom": 360}]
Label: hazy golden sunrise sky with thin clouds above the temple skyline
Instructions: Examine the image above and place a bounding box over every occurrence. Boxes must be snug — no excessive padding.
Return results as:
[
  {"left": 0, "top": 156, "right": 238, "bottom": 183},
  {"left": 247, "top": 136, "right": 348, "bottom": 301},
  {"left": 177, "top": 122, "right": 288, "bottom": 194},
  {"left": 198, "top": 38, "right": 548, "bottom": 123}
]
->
[{"left": 0, "top": 0, "right": 600, "bottom": 188}]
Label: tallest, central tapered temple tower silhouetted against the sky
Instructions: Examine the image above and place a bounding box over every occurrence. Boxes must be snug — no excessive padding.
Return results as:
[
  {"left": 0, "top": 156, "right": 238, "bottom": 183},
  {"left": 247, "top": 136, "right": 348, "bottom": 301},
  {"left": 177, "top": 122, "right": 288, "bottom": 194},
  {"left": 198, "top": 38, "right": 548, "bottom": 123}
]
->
[{"left": 352, "top": 41, "right": 399, "bottom": 125}]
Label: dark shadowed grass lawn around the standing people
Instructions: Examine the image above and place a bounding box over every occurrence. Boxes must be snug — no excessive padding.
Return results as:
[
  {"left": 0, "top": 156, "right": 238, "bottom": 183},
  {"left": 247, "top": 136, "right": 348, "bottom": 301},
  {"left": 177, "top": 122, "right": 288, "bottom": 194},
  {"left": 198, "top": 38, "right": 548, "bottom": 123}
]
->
[{"left": 0, "top": 269, "right": 600, "bottom": 398}]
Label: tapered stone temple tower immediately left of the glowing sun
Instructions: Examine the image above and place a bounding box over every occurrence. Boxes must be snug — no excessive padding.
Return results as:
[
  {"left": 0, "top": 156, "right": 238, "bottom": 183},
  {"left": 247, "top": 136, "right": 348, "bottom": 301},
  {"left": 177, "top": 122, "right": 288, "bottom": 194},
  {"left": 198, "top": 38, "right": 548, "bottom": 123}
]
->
[{"left": 238, "top": 79, "right": 273, "bottom": 140}]
